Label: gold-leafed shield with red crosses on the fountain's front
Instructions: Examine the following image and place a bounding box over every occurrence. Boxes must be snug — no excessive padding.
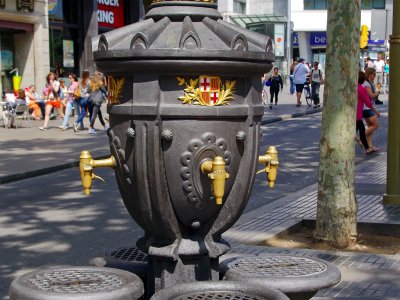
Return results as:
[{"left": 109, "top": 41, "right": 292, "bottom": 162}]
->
[{"left": 176, "top": 75, "right": 236, "bottom": 106}]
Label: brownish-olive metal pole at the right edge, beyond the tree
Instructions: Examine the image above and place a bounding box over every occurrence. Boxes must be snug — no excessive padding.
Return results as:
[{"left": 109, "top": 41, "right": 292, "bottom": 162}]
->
[{"left": 383, "top": 1, "right": 400, "bottom": 205}]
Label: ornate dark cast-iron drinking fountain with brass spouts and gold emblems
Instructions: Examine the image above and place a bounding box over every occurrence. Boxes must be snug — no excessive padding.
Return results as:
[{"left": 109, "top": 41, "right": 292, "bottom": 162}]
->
[{"left": 80, "top": 0, "right": 278, "bottom": 294}]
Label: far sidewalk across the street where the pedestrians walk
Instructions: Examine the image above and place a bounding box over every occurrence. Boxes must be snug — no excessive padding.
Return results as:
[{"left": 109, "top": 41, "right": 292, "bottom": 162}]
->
[{"left": 0, "top": 89, "right": 323, "bottom": 184}]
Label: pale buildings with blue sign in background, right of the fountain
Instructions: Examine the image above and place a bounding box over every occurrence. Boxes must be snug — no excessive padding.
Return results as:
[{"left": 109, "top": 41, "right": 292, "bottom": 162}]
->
[{"left": 218, "top": 0, "right": 393, "bottom": 73}]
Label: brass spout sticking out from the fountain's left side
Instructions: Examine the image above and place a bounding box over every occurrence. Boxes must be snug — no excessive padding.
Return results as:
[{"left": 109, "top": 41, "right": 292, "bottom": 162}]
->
[{"left": 79, "top": 151, "right": 116, "bottom": 195}]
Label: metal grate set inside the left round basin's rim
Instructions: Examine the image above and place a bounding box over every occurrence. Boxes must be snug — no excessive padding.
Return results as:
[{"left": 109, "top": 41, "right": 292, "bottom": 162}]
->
[{"left": 24, "top": 270, "right": 123, "bottom": 293}]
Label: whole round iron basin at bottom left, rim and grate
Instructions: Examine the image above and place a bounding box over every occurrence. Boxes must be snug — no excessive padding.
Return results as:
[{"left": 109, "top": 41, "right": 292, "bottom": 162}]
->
[{"left": 9, "top": 267, "right": 144, "bottom": 300}]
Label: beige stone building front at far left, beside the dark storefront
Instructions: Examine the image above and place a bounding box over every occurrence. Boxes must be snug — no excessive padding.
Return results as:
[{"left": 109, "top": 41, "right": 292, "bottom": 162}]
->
[{"left": 0, "top": 0, "right": 50, "bottom": 93}]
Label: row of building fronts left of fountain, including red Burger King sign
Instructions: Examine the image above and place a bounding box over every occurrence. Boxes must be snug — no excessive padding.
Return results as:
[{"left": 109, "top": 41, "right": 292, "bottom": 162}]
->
[{"left": 0, "top": 0, "right": 141, "bottom": 93}]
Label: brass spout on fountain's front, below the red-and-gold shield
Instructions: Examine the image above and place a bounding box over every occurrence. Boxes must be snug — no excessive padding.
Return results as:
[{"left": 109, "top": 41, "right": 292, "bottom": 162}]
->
[{"left": 200, "top": 156, "right": 229, "bottom": 205}]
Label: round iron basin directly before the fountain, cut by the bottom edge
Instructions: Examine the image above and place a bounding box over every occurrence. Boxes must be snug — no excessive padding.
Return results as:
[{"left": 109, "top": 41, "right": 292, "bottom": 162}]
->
[{"left": 151, "top": 281, "right": 289, "bottom": 300}]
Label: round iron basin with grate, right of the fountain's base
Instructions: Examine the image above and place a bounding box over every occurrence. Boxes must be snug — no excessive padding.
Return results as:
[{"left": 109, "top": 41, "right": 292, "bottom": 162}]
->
[{"left": 220, "top": 254, "right": 341, "bottom": 293}]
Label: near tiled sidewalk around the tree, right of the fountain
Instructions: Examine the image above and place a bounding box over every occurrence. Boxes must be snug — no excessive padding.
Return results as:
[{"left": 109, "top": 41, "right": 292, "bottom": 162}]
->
[{"left": 223, "top": 153, "right": 400, "bottom": 300}]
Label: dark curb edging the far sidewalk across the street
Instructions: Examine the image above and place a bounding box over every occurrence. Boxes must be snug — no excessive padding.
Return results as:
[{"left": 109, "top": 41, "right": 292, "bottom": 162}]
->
[{"left": 0, "top": 108, "right": 322, "bottom": 184}]
